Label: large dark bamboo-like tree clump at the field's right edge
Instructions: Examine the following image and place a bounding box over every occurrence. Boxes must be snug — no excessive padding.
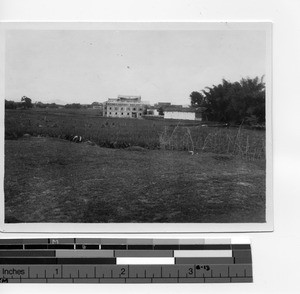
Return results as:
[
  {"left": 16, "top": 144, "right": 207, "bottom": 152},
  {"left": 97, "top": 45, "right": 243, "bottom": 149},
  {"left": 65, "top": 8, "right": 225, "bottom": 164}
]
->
[{"left": 190, "top": 77, "right": 265, "bottom": 125}]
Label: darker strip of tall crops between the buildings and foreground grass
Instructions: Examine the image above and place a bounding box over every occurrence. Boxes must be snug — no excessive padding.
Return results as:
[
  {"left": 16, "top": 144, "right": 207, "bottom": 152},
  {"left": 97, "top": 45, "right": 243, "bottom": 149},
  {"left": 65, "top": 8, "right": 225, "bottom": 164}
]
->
[{"left": 5, "top": 109, "right": 265, "bottom": 160}]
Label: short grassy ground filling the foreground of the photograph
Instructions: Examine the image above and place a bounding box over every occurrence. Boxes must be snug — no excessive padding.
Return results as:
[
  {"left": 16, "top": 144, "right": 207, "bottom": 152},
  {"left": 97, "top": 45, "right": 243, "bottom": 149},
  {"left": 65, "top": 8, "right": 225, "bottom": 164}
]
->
[{"left": 5, "top": 137, "right": 265, "bottom": 223}]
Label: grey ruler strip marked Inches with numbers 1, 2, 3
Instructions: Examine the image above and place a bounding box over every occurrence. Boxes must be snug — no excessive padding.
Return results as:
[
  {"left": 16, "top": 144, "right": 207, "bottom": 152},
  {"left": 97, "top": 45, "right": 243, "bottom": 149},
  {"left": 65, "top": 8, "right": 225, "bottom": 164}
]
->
[{"left": 0, "top": 264, "right": 252, "bottom": 280}]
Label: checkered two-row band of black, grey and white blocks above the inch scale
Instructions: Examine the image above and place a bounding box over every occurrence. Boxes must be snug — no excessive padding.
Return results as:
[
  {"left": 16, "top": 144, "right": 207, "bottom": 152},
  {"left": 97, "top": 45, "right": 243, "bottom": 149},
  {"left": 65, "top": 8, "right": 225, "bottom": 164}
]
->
[{"left": 0, "top": 250, "right": 252, "bottom": 265}]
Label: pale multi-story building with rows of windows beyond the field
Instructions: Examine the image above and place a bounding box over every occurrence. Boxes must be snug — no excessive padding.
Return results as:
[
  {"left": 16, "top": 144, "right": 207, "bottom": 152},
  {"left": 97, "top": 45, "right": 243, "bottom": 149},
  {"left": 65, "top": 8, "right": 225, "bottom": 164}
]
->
[{"left": 103, "top": 95, "right": 149, "bottom": 118}]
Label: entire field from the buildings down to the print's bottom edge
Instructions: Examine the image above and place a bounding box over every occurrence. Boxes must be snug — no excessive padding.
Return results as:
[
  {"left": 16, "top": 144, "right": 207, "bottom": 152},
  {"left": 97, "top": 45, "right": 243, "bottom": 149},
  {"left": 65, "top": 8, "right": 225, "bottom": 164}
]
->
[{"left": 4, "top": 110, "right": 266, "bottom": 223}]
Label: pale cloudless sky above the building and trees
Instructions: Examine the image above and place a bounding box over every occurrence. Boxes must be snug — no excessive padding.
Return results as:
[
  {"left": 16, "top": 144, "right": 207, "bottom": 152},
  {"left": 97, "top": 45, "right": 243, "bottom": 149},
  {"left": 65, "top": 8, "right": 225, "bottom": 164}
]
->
[{"left": 5, "top": 30, "right": 266, "bottom": 105}]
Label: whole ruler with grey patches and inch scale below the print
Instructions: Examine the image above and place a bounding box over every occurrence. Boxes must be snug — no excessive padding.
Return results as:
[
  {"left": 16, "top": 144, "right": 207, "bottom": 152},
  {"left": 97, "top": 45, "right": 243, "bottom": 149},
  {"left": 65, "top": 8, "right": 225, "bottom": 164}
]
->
[{"left": 0, "top": 238, "right": 253, "bottom": 283}]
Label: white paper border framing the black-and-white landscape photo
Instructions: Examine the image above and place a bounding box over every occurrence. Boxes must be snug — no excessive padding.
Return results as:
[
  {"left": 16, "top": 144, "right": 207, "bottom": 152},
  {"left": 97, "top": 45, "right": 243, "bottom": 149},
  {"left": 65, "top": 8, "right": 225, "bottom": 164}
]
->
[{"left": 0, "top": 21, "right": 273, "bottom": 234}]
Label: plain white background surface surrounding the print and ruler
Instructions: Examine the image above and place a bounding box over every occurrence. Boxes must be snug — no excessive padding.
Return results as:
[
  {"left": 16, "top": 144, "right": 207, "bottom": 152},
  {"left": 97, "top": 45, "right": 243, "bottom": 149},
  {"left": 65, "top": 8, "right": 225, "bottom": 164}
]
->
[{"left": 0, "top": 0, "right": 300, "bottom": 294}]
